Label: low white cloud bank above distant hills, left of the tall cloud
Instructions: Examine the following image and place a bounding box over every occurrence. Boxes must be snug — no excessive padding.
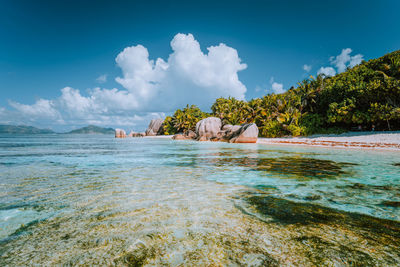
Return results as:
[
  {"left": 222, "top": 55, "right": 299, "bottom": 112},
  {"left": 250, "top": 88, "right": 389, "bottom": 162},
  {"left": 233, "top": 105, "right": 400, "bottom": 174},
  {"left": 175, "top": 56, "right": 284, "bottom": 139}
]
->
[{"left": 4, "top": 87, "right": 166, "bottom": 130}]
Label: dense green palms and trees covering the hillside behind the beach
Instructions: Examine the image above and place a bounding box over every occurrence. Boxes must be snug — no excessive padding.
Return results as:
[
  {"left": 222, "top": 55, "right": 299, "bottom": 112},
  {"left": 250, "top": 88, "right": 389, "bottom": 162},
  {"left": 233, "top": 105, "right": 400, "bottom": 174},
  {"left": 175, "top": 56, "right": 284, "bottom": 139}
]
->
[{"left": 164, "top": 50, "right": 400, "bottom": 137}]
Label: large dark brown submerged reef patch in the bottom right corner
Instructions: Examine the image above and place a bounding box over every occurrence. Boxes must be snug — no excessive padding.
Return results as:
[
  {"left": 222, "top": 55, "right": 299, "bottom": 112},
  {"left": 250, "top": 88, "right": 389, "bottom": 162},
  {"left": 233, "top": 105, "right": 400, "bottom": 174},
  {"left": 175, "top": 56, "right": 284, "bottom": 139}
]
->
[{"left": 238, "top": 192, "right": 400, "bottom": 266}]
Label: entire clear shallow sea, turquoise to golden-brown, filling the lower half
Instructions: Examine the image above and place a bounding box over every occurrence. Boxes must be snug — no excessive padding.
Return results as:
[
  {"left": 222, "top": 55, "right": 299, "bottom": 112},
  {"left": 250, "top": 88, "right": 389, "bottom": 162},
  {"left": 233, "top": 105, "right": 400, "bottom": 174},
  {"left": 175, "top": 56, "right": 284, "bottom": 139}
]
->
[{"left": 0, "top": 135, "right": 400, "bottom": 266}]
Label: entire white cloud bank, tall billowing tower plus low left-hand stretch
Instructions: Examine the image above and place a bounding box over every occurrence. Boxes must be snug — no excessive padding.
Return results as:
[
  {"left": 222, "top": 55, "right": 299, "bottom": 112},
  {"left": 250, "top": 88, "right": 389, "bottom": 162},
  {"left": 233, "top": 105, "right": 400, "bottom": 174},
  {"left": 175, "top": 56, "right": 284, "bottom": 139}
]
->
[{"left": 0, "top": 34, "right": 247, "bottom": 130}]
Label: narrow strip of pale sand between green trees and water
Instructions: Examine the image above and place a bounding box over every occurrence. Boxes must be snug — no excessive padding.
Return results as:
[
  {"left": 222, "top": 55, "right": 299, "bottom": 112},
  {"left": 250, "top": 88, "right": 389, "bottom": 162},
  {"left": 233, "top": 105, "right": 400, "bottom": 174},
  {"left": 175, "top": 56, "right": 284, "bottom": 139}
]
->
[{"left": 257, "top": 131, "right": 400, "bottom": 151}]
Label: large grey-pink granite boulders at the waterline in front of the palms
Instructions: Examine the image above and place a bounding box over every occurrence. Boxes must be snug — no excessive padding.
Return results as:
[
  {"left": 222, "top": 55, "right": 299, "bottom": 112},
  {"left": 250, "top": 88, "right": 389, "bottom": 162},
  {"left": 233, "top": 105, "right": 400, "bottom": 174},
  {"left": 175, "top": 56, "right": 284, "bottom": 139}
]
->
[{"left": 173, "top": 117, "right": 258, "bottom": 143}]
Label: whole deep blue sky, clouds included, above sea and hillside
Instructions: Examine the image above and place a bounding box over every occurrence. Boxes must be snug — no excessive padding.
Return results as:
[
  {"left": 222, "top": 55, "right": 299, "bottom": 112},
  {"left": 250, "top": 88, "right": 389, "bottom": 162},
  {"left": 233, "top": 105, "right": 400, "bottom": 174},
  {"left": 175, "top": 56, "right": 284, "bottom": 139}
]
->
[{"left": 0, "top": 0, "right": 400, "bottom": 130}]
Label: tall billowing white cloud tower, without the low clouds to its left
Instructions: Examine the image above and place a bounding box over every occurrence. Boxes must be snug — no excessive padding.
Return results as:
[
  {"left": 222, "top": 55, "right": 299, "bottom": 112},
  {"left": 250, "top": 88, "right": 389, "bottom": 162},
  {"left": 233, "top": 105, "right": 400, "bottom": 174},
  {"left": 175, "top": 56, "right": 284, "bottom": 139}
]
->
[{"left": 116, "top": 34, "right": 247, "bottom": 111}]
